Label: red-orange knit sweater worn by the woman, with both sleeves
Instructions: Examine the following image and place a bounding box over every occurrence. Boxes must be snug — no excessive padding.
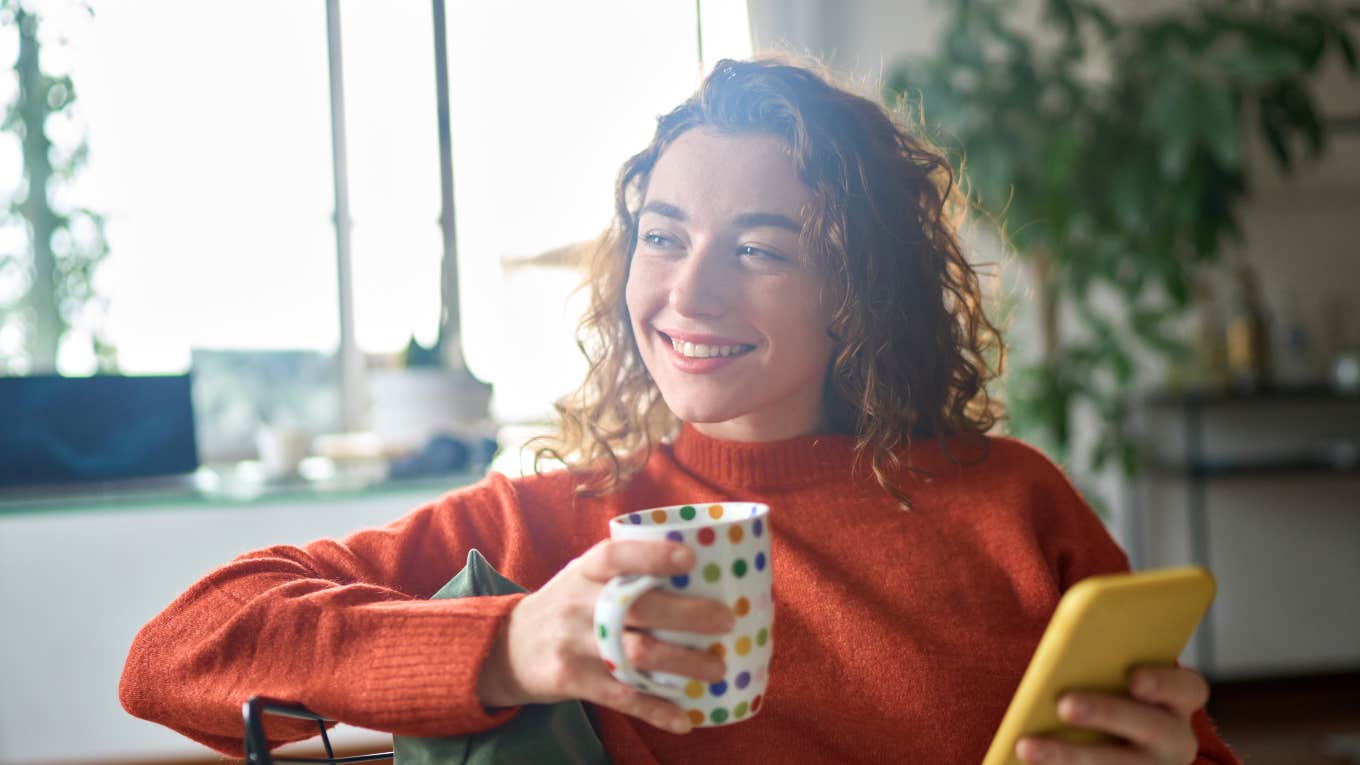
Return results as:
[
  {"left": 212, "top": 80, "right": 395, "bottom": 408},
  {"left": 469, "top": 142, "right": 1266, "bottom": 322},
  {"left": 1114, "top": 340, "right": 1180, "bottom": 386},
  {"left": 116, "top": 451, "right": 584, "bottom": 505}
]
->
[{"left": 120, "top": 426, "right": 1238, "bottom": 764}]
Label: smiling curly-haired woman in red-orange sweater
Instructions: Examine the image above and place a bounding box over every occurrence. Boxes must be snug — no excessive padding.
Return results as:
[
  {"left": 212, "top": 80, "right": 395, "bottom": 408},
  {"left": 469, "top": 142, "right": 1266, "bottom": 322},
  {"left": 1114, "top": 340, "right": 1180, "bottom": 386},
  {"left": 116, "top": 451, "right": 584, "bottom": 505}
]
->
[{"left": 121, "top": 61, "right": 1236, "bottom": 765}]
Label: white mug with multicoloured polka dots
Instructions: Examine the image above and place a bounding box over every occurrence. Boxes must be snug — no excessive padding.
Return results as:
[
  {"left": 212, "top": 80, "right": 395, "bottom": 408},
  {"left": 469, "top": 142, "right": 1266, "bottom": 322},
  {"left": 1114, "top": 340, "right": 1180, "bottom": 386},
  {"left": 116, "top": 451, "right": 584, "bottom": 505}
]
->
[{"left": 594, "top": 502, "right": 774, "bottom": 727}]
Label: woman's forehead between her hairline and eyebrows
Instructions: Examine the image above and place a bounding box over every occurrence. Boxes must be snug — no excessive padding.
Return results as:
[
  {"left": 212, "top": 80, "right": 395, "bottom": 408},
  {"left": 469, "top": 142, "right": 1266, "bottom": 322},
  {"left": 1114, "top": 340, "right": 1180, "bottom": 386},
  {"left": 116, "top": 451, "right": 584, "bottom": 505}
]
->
[{"left": 646, "top": 128, "right": 812, "bottom": 221}]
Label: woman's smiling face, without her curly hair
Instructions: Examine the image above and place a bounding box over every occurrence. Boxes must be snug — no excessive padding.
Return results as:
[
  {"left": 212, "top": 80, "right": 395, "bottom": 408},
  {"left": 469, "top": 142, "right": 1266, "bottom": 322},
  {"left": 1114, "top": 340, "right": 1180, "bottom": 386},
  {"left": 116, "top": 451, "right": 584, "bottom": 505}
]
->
[{"left": 627, "top": 128, "right": 831, "bottom": 441}]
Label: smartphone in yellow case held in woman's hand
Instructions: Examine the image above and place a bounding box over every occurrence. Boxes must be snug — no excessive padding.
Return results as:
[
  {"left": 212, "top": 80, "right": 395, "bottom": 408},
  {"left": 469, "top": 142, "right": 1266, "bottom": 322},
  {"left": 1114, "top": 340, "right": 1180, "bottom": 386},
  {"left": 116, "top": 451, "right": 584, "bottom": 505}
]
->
[{"left": 982, "top": 566, "right": 1214, "bottom": 765}]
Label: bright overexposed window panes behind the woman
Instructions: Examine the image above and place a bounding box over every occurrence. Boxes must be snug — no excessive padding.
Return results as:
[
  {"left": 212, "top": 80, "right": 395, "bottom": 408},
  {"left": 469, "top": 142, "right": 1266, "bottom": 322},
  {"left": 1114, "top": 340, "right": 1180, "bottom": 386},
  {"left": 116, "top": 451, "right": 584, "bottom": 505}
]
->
[{"left": 0, "top": 0, "right": 749, "bottom": 470}]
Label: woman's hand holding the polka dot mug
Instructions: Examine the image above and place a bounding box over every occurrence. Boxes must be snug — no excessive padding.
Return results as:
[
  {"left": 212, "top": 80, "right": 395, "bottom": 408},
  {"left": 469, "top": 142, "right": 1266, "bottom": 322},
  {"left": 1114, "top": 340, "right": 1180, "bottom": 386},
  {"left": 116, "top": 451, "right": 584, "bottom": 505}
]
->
[{"left": 477, "top": 539, "right": 736, "bottom": 734}]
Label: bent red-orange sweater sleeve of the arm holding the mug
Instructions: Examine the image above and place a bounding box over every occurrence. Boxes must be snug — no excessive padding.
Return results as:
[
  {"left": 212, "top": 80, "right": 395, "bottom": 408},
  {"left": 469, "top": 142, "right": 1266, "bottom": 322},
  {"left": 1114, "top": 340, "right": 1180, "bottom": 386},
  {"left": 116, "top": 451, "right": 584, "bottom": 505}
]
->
[{"left": 120, "top": 474, "right": 537, "bottom": 755}]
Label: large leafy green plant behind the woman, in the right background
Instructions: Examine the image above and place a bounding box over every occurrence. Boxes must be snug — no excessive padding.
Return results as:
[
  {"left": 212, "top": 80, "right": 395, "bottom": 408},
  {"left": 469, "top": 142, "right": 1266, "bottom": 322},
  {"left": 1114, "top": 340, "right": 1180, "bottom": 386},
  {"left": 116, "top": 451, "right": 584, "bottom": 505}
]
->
[{"left": 885, "top": 0, "right": 1360, "bottom": 474}]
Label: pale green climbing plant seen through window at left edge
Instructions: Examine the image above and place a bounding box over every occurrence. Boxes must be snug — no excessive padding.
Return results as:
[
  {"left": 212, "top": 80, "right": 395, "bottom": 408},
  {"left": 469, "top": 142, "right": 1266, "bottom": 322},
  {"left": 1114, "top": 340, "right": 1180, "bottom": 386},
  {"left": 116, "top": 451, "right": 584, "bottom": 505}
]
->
[{"left": 0, "top": 0, "right": 117, "bottom": 373}]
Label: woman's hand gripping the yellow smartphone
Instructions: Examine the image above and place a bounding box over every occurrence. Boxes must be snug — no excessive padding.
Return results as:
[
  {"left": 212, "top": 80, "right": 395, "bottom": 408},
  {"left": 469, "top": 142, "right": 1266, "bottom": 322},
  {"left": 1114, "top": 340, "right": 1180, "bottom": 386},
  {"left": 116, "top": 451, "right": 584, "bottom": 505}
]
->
[{"left": 1016, "top": 666, "right": 1209, "bottom": 765}]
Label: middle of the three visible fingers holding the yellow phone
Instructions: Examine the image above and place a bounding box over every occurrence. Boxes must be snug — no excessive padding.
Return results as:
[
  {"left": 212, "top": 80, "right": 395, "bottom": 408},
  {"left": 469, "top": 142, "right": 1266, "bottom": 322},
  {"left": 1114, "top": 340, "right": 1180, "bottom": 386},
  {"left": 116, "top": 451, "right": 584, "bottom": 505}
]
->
[{"left": 1058, "top": 691, "right": 1198, "bottom": 762}]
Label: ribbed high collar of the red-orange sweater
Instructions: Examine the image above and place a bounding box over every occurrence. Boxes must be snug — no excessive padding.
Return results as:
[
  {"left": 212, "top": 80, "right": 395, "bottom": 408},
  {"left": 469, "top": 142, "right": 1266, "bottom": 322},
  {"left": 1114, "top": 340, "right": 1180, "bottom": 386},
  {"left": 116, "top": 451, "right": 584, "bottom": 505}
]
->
[{"left": 670, "top": 423, "right": 854, "bottom": 489}]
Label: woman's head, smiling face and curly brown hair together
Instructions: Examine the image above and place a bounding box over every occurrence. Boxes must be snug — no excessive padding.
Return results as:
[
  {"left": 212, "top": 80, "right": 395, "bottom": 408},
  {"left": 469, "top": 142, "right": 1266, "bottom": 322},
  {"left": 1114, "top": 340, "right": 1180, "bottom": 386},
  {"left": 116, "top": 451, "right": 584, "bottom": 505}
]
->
[{"left": 539, "top": 59, "right": 1005, "bottom": 505}]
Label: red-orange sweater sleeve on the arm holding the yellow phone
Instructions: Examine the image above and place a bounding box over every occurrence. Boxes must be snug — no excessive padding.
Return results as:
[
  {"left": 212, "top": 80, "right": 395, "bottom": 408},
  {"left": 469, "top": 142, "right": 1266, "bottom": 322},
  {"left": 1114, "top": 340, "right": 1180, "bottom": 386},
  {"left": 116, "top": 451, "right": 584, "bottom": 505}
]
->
[{"left": 1031, "top": 441, "right": 1242, "bottom": 765}]
